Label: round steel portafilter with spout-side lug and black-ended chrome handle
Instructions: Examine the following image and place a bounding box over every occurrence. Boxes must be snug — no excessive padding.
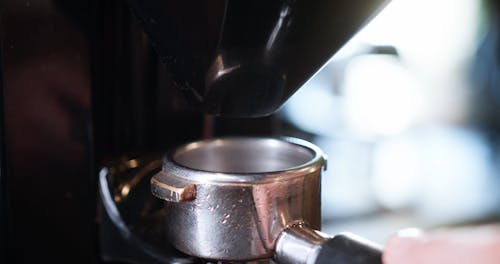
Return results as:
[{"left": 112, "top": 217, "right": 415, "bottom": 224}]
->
[{"left": 151, "top": 138, "right": 381, "bottom": 264}]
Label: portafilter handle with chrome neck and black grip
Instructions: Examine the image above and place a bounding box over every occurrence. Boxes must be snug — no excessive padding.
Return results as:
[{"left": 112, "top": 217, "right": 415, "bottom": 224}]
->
[{"left": 274, "top": 223, "right": 382, "bottom": 264}]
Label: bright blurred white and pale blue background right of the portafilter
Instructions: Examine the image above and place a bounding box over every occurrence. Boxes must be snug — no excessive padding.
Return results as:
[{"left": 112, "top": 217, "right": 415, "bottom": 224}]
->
[{"left": 278, "top": 0, "right": 500, "bottom": 243}]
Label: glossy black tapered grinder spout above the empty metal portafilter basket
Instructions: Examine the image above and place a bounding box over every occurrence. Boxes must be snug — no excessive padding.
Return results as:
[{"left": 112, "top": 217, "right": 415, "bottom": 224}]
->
[{"left": 128, "top": 0, "right": 389, "bottom": 117}]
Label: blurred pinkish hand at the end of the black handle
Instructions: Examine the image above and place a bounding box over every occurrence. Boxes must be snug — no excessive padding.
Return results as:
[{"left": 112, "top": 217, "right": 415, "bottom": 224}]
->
[{"left": 382, "top": 225, "right": 500, "bottom": 264}]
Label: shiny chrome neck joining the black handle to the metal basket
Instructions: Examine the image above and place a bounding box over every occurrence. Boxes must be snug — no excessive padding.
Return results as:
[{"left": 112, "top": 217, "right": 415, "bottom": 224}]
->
[{"left": 274, "top": 223, "right": 329, "bottom": 264}]
